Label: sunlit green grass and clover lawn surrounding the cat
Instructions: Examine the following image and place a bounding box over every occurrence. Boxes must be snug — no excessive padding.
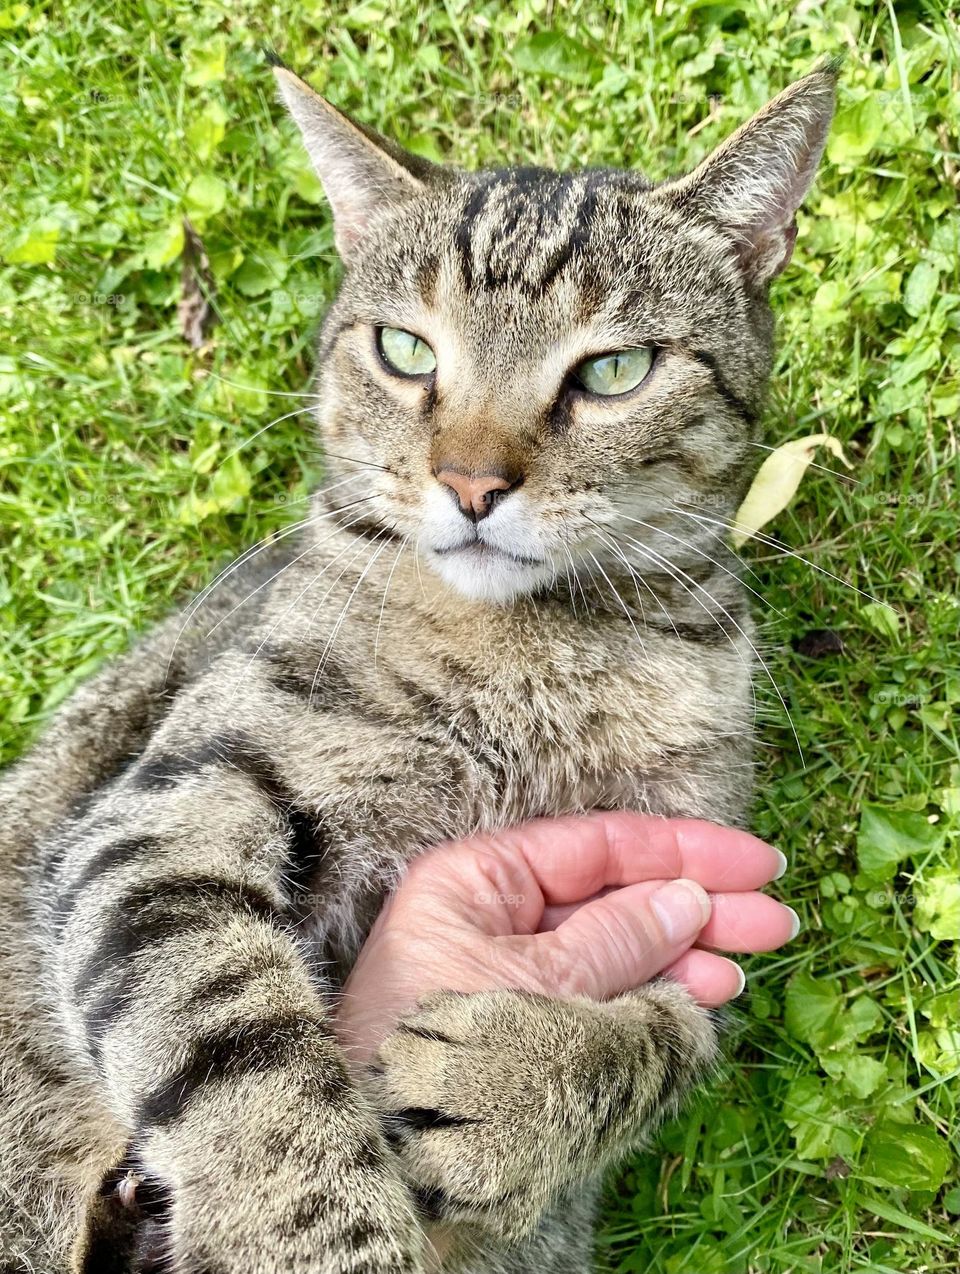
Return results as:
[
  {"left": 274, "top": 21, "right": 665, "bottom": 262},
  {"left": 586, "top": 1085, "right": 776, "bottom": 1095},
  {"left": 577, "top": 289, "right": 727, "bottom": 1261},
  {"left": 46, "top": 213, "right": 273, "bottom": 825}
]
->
[{"left": 0, "top": 0, "right": 960, "bottom": 1274}]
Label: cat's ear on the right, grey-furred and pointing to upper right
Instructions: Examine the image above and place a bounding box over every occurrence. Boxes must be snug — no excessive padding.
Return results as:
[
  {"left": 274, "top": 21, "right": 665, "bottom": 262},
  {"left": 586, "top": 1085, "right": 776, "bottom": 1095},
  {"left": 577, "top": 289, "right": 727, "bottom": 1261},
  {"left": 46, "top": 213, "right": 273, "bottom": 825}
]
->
[{"left": 654, "top": 59, "right": 840, "bottom": 287}]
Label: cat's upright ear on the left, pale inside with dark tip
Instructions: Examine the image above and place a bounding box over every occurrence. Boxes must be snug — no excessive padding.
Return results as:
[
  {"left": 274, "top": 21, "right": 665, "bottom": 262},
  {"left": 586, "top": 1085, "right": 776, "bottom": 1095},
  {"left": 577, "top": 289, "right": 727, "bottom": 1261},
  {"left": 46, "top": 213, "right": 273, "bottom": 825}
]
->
[{"left": 274, "top": 64, "right": 434, "bottom": 261}]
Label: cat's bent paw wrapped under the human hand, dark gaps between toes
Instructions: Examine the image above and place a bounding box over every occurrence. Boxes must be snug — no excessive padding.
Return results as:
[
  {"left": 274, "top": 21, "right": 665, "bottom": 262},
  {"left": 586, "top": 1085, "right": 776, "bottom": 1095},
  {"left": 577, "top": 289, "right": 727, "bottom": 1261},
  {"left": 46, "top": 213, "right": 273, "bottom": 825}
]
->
[{"left": 369, "top": 982, "right": 716, "bottom": 1241}]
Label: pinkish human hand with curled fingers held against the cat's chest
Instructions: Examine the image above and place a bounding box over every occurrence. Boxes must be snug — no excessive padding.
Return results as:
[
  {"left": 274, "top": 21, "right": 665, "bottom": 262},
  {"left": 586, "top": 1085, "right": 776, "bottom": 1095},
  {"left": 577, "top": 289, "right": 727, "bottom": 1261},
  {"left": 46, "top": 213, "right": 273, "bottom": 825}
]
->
[{"left": 337, "top": 810, "right": 797, "bottom": 1064}]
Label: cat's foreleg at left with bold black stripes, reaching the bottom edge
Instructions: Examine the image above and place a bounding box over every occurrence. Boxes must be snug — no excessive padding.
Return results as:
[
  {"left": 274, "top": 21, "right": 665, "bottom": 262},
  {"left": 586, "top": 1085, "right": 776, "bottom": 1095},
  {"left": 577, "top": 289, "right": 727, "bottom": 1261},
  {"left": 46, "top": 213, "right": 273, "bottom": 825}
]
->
[{"left": 36, "top": 662, "right": 453, "bottom": 1274}]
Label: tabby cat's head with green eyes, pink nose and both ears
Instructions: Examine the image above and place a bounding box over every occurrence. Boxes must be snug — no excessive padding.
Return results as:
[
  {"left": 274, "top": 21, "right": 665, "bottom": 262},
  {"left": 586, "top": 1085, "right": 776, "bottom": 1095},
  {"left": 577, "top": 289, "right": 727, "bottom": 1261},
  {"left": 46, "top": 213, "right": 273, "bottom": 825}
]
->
[{"left": 276, "top": 64, "right": 836, "bottom": 603}]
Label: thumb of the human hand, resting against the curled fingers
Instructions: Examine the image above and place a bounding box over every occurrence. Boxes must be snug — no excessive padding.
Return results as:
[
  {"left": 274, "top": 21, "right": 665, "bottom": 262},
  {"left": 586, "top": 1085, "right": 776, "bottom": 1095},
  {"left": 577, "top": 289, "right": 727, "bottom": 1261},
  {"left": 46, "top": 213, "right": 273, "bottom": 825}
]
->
[{"left": 532, "top": 880, "right": 710, "bottom": 1000}]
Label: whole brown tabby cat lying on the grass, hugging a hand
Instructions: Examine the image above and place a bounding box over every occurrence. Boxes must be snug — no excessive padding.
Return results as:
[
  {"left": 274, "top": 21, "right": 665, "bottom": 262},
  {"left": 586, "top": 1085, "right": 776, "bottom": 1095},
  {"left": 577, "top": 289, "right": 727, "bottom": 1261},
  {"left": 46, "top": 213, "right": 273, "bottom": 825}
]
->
[{"left": 0, "top": 52, "right": 836, "bottom": 1274}]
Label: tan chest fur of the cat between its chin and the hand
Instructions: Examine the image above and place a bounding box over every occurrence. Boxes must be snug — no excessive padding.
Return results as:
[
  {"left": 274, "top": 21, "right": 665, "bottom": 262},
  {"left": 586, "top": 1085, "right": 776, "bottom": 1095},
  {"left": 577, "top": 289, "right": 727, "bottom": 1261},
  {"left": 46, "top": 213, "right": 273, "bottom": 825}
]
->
[{"left": 250, "top": 542, "right": 752, "bottom": 973}]
